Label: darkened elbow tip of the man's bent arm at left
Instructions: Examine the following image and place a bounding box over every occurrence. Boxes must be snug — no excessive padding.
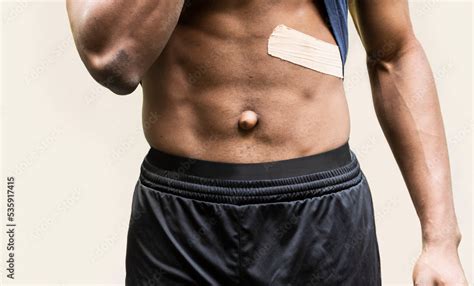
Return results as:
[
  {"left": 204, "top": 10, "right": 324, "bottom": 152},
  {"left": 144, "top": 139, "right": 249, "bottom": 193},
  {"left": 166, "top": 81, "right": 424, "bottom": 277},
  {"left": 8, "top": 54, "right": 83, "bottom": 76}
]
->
[{"left": 85, "top": 50, "right": 140, "bottom": 95}]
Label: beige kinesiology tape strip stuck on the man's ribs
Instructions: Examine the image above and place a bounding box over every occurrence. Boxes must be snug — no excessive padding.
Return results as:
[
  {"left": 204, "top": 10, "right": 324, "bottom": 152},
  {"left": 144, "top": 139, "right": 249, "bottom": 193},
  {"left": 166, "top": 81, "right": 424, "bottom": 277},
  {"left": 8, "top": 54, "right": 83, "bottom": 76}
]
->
[{"left": 268, "top": 25, "right": 343, "bottom": 78}]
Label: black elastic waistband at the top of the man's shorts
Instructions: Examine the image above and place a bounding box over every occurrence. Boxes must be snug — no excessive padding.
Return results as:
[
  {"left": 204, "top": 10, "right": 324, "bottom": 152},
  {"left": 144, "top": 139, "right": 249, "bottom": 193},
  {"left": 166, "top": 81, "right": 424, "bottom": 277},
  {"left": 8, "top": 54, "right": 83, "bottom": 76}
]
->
[{"left": 140, "top": 143, "right": 363, "bottom": 205}]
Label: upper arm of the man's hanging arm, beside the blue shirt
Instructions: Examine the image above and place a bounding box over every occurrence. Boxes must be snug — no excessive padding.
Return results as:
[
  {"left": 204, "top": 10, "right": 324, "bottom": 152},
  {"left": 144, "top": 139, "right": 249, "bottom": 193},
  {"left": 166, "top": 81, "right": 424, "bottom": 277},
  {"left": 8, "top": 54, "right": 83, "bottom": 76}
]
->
[{"left": 349, "top": 0, "right": 415, "bottom": 61}]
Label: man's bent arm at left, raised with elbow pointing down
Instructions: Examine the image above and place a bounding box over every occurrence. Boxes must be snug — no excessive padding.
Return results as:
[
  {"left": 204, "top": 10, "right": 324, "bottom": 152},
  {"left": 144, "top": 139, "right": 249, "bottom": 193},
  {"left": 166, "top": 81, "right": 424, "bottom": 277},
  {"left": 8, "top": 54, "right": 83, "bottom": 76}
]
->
[{"left": 67, "top": 0, "right": 183, "bottom": 94}]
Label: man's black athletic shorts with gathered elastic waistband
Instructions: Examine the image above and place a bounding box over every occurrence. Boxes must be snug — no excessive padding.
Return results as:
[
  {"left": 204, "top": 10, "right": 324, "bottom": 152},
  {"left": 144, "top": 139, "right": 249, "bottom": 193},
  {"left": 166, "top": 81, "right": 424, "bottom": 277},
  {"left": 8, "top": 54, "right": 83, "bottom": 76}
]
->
[{"left": 126, "top": 143, "right": 381, "bottom": 286}]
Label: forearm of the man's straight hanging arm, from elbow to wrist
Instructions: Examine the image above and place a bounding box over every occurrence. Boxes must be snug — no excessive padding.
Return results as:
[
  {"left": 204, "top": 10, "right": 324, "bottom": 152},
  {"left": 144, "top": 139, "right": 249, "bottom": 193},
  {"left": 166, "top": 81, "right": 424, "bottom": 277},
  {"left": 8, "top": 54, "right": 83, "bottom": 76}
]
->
[{"left": 368, "top": 39, "right": 461, "bottom": 247}]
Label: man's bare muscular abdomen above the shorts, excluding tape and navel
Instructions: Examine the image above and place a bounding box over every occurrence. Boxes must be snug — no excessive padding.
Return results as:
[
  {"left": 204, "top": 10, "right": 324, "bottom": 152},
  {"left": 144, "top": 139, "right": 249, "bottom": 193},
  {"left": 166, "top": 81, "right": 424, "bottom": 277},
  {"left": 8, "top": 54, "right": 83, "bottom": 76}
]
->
[{"left": 142, "top": 1, "right": 350, "bottom": 163}]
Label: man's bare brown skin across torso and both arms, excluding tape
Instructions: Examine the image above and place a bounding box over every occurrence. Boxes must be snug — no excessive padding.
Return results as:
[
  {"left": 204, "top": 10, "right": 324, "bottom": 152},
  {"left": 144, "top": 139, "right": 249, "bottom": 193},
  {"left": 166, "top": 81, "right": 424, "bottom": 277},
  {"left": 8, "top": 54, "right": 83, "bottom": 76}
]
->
[{"left": 67, "top": 0, "right": 467, "bottom": 285}]
